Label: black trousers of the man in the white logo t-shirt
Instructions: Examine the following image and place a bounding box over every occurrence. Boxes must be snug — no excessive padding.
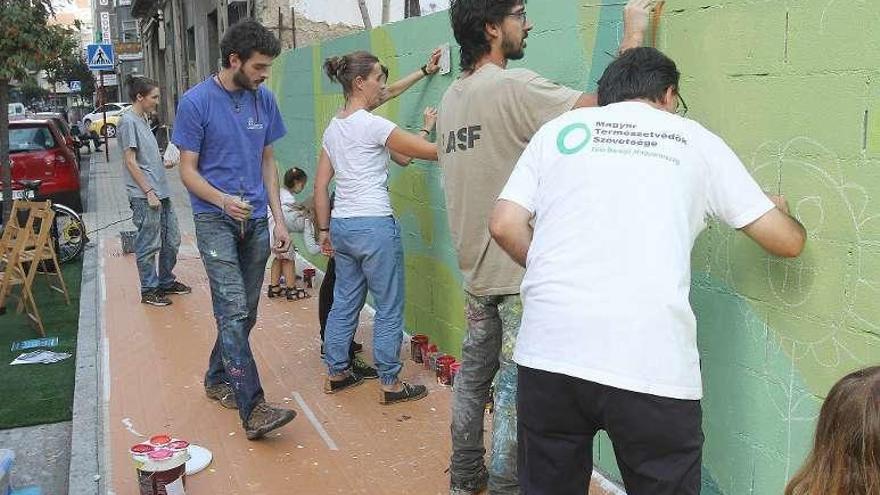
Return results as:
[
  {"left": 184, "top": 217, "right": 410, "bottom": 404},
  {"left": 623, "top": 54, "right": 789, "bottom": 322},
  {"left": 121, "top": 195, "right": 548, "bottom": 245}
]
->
[{"left": 517, "top": 366, "right": 703, "bottom": 495}]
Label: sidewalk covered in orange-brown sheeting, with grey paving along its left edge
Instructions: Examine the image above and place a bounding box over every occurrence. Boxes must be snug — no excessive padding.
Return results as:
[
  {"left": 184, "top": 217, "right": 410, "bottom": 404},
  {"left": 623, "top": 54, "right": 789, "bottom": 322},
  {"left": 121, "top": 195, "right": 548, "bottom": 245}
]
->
[{"left": 70, "top": 138, "right": 620, "bottom": 495}]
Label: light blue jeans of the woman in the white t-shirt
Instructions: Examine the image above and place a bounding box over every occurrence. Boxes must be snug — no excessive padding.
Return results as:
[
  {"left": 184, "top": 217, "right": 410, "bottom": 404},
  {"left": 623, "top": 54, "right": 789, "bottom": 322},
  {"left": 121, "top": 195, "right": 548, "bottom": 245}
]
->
[{"left": 324, "top": 217, "right": 403, "bottom": 385}]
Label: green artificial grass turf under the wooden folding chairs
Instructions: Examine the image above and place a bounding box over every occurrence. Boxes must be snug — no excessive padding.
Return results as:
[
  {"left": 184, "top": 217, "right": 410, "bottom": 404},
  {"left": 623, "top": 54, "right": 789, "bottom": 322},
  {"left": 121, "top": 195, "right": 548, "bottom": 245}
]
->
[{"left": 0, "top": 259, "right": 82, "bottom": 430}]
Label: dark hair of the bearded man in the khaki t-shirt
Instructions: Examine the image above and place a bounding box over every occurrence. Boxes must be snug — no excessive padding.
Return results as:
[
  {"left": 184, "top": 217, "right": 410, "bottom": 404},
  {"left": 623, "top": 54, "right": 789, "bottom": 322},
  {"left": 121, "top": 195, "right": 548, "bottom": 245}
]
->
[{"left": 449, "top": 0, "right": 525, "bottom": 72}]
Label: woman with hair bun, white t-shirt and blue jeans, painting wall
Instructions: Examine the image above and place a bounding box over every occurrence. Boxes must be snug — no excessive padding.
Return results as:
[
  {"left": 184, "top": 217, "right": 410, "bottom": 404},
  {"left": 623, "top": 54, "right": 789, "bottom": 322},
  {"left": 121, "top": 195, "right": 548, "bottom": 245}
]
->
[{"left": 315, "top": 50, "right": 439, "bottom": 404}]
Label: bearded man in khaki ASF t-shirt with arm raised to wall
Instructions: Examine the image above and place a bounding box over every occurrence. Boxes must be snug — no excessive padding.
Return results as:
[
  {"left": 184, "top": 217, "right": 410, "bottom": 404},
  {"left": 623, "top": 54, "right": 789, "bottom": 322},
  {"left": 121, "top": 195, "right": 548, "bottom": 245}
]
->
[{"left": 437, "top": 0, "right": 653, "bottom": 495}]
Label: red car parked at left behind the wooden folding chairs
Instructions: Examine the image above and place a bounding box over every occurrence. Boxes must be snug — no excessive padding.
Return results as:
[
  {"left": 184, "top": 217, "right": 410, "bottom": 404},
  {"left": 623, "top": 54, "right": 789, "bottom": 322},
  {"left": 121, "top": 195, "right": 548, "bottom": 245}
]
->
[{"left": 0, "top": 119, "right": 82, "bottom": 212}]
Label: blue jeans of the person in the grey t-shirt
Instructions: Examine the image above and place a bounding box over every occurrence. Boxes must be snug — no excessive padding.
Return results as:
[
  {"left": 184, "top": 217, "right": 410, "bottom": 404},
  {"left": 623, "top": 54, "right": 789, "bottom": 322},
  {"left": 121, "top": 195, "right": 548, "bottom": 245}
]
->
[{"left": 129, "top": 198, "right": 180, "bottom": 294}]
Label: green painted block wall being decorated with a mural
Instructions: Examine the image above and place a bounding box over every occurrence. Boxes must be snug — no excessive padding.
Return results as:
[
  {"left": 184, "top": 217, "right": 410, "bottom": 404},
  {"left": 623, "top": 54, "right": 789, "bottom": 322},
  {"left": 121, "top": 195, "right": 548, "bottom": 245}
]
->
[{"left": 271, "top": 0, "right": 880, "bottom": 495}]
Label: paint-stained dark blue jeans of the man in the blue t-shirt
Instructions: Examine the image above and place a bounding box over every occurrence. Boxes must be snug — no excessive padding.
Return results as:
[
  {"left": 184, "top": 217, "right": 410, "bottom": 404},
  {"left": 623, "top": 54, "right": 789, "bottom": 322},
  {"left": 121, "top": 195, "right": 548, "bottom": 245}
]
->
[{"left": 193, "top": 213, "right": 269, "bottom": 422}]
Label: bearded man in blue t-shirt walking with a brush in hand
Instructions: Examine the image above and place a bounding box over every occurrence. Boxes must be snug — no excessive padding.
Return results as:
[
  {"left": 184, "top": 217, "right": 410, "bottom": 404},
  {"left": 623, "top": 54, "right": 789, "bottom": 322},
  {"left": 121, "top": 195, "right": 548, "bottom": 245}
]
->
[{"left": 171, "top": 19, "right": 296, "bottom": 440}]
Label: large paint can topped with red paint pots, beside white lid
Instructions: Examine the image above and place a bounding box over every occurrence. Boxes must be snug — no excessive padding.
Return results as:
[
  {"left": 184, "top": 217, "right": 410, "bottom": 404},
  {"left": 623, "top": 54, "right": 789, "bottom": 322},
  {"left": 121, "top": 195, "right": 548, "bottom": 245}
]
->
[{"left": 129, "top": 435, "right": 189, "bottom": 495}]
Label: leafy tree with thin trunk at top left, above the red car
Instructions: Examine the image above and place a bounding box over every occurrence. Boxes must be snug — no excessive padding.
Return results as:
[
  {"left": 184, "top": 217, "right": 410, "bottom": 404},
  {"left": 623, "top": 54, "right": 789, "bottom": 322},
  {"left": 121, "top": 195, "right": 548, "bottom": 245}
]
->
[{"left": 0, "top": 0, "right": 70, "bottom": 221}]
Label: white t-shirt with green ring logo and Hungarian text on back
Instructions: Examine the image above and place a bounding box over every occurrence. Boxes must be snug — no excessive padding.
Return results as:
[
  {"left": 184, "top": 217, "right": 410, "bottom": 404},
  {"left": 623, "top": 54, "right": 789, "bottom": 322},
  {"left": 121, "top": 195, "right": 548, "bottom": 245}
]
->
[{"left": 500, "top": 102, "right": 773, "bottom": 400}]
